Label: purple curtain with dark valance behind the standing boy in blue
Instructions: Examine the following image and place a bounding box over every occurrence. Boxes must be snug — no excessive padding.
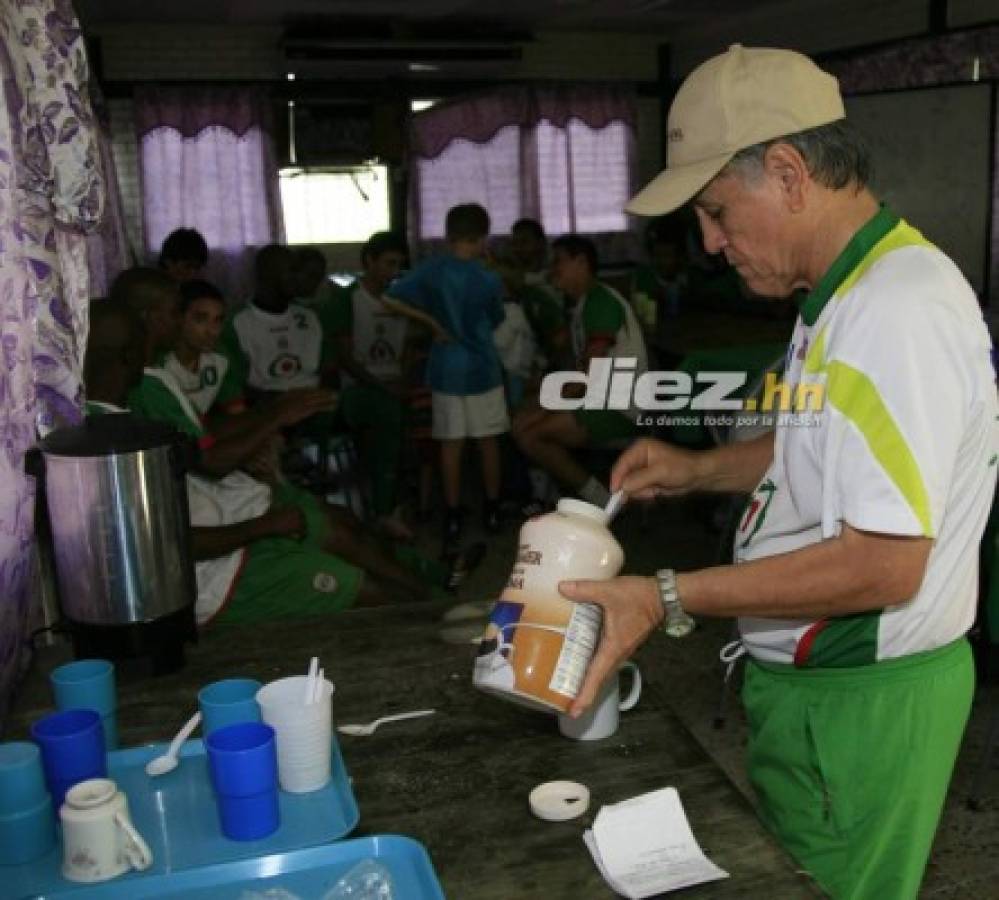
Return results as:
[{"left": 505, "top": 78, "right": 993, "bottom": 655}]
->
[{"left": 410, "top": 85, "right": 637, "bottom": 260}]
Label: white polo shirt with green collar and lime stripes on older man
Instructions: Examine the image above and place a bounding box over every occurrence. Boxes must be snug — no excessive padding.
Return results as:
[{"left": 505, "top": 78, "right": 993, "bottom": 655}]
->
[{"left": 735, "top": 208, "right": 999, "bottom": 666}]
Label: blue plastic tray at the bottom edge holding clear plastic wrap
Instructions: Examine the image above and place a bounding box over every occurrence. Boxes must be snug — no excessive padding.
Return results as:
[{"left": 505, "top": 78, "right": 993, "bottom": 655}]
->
[{"left": 30, "top": 835, "right": 444, "bottom": 900}]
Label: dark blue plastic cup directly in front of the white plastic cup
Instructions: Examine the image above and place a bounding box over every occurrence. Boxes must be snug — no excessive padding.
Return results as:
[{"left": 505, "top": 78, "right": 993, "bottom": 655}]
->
[{"left": 205, "top": 722, "right": 280, "bottom": 841}]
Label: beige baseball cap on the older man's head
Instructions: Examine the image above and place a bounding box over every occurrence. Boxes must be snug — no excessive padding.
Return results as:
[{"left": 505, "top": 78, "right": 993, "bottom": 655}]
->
[{"left": 625, "top": 44, "right": 846, "bottom": 216}]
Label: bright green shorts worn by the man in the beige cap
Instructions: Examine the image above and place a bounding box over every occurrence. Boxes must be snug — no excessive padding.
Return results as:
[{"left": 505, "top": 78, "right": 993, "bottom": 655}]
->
[{"left": 742, "top": 638, "right": 974, "bottom": 900}]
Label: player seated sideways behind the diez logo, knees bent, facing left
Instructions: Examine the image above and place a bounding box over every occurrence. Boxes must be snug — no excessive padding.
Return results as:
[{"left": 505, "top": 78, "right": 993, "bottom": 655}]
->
[{"left": 513, "top": 235, "right": 647, "bottom": 506}]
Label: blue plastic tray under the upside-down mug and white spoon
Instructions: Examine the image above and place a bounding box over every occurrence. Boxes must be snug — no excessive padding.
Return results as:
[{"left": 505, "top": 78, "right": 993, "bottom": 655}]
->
[{"left": 6, "top": 738, "right": 358, "bottom": 898}]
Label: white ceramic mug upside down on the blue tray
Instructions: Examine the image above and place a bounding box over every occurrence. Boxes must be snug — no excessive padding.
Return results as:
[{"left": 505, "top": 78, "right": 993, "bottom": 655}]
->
[{"left": 59, "top": 778, "right": 153, "bottom": 883}]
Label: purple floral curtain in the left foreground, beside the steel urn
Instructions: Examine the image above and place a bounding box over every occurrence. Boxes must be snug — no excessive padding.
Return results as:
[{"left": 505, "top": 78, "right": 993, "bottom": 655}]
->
[{"left": 0, "top": 0, "right": 104, "bottom": 715}]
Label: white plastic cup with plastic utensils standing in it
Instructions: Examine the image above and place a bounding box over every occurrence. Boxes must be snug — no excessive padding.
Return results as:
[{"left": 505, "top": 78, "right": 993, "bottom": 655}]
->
[{"left": 257, "top": 675, "right": 333, "bottom": 794}]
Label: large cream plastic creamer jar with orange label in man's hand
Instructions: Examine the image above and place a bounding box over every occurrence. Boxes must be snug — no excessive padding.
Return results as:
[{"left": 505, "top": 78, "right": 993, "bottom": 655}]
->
[{"left": 472, "top": 499, "right": 624, "bottom": 713}]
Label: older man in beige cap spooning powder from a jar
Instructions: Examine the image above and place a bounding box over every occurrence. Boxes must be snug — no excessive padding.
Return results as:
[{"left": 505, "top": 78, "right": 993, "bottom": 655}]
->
[{"left": 562, "top": 45, "right": 999, "bottom": 900}]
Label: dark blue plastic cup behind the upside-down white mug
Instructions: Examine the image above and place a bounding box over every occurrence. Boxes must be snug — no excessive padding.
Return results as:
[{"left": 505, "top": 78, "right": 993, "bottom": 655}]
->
[{"left": 31, "top": 709, "right": 108, "bottom": 810}]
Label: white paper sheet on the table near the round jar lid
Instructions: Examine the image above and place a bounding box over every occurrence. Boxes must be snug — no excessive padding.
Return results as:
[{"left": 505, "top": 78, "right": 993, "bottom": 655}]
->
[{"left": 583, "top": 788, "right": 728, "bottom": 900}]
